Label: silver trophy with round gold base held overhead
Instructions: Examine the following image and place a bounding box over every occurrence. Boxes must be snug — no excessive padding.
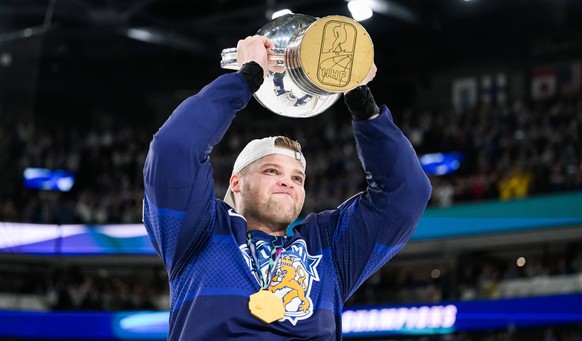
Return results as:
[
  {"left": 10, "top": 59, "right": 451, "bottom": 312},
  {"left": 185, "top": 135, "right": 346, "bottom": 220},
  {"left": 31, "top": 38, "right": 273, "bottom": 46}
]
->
[{"left": 220, "top": 14, "right": 374, "bottom": 118}]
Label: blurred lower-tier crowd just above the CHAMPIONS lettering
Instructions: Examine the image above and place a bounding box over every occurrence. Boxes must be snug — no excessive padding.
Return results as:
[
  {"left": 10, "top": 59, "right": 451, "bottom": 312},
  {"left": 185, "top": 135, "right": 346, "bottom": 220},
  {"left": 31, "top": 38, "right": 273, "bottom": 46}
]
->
[{"left": 349, "top": 242, "right": 582, "bottom": 305}]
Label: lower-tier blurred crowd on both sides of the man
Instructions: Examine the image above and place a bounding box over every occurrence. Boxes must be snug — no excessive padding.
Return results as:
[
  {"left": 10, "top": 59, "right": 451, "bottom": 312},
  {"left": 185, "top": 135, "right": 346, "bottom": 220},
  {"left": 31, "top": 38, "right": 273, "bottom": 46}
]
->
[{"left": 0, "top": 241, "right": 582, "bottom": 311}]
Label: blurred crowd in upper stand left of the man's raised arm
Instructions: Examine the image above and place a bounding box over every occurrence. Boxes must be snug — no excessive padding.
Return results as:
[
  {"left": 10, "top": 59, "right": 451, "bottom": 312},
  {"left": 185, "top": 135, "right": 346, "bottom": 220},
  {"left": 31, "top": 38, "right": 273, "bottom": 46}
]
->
[{"left": 0, "top": 122, "right": 151, "bottom": 224}]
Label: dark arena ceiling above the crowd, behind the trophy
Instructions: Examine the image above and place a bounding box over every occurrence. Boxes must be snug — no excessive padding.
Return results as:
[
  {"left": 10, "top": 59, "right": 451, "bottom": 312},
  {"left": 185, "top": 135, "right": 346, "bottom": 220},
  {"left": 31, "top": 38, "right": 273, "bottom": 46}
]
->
[{"left": 0, "top": 0, "right": 582, "bottom": 123}]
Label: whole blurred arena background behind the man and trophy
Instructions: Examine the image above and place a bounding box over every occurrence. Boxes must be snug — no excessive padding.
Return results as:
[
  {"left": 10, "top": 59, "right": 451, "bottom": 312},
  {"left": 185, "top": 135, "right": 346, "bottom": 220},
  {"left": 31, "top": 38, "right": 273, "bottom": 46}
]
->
[{"left": 0, "top": 0, "right": 582, "bottom": 340}]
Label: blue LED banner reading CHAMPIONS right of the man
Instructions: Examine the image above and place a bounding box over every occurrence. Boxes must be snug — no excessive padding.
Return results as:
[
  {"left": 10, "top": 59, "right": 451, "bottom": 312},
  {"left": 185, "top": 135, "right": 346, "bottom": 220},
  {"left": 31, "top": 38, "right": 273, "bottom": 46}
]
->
[{"left": 343, "top": 294, "right": 582, "bottom": 337}]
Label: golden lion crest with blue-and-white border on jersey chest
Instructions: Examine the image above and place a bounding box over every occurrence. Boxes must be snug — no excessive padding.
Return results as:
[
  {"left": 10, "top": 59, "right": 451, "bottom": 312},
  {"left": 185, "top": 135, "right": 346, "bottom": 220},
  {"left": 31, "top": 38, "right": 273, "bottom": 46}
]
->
[{"left": 241, "top": 240, "right": 321, "bottom": 325}]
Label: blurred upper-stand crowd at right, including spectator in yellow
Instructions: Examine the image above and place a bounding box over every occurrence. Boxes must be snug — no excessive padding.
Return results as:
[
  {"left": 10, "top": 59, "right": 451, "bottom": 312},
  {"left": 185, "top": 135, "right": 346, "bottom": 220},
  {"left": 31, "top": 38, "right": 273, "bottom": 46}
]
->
[{"left": 408, "top": 97, "right": 582, "bottom": 206}]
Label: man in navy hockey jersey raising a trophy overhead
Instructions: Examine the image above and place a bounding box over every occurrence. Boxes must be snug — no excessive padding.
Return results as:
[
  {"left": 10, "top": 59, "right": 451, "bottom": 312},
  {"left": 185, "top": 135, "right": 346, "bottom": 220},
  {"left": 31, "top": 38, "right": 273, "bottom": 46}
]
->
[{"left": 144, "top": 13, "right": 431, "bottom": 340}]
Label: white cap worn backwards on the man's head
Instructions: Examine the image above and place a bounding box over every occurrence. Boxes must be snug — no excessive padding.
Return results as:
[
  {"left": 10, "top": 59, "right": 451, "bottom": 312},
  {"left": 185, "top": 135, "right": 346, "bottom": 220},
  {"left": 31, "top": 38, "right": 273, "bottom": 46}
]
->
[{"left": 224, "top": 136, "right": 307, "bottom": 207}]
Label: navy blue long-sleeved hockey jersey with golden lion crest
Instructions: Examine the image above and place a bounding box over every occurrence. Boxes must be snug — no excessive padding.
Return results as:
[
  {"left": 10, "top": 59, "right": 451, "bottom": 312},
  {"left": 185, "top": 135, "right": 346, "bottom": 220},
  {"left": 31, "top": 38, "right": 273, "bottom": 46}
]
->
[{"left": 144, "top": 73, "right": 430, "bottom": 341}]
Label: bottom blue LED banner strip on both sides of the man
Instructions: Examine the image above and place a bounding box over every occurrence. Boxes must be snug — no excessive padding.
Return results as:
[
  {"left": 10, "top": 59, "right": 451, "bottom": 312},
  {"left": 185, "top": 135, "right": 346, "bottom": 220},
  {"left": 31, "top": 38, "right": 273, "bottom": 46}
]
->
[{"left": 0, "top": 294, "right": 582, "bottom": 340}]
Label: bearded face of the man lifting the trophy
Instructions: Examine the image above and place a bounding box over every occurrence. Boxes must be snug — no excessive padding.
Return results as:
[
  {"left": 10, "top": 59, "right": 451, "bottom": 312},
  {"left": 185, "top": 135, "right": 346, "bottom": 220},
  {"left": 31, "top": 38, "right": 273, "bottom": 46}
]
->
[{"left": 237, "top": 154, "right": 305, "bottom": 227}]
